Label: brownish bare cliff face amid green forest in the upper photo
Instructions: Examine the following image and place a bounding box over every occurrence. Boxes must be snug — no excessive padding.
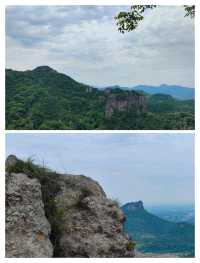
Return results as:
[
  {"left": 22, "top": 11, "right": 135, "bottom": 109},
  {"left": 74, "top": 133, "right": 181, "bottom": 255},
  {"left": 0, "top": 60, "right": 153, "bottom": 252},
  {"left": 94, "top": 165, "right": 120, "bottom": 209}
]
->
[{"left": 105, "top": 90, "right": 146, "bottom": 118}]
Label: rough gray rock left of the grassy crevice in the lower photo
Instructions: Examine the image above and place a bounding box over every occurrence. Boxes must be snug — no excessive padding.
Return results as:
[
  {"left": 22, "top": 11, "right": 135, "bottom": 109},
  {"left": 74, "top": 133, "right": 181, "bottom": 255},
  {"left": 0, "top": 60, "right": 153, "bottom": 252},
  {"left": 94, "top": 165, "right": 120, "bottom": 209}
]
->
[{"left": 6, "top": 172, "right": 53, "bottom": 257}]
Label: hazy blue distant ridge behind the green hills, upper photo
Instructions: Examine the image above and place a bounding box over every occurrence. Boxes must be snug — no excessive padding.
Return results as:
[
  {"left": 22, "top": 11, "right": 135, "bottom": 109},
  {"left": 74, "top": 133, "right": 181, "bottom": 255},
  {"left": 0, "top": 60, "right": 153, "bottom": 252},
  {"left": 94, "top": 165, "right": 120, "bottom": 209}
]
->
[{"left": 133, "top": 84, "right": 195, "bottom": 100}]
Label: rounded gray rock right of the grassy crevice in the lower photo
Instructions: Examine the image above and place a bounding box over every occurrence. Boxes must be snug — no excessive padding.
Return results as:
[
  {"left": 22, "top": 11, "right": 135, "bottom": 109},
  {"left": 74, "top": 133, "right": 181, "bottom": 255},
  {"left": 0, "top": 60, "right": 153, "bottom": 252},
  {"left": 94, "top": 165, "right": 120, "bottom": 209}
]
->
[{"left": 56, "top": 175, "right": 134, "bottom": 257}]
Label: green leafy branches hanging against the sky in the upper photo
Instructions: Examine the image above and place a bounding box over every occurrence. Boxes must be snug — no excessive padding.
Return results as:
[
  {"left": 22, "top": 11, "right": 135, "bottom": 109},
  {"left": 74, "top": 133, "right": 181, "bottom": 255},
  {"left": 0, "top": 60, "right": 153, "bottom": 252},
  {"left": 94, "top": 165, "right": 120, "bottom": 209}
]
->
[{"left": 115, "top": 5, "right": 195, "bottom": 34}]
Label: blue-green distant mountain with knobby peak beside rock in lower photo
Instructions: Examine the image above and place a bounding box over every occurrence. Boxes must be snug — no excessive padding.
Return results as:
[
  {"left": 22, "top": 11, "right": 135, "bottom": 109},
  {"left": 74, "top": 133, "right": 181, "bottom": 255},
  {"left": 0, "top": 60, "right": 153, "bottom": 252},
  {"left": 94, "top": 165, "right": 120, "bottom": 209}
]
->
[{"left": 122, "top": 201, "right": 194, "bottom": 256}]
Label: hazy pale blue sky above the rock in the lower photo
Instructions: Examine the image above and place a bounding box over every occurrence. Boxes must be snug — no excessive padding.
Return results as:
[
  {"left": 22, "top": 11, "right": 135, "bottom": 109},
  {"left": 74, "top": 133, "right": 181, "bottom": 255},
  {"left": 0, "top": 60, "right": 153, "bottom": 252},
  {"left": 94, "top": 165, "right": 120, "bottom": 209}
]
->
[{"left": 6, "top": 133, "right": 194, "bottom": 205}]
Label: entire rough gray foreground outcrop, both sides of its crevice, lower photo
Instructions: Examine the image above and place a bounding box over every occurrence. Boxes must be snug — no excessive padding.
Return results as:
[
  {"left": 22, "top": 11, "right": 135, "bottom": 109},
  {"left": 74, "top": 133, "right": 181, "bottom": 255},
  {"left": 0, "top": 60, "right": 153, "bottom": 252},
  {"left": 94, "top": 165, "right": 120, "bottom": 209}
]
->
[{"left": 6, "top": 156, "right": 134, "bottom": 257}]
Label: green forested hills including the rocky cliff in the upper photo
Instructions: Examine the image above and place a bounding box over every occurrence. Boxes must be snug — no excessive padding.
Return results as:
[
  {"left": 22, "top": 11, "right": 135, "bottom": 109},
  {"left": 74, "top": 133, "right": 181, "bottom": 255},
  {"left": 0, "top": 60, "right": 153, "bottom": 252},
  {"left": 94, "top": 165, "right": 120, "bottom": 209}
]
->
[{"left": 6, "top": 66, "right": 194, "bottom": 130}]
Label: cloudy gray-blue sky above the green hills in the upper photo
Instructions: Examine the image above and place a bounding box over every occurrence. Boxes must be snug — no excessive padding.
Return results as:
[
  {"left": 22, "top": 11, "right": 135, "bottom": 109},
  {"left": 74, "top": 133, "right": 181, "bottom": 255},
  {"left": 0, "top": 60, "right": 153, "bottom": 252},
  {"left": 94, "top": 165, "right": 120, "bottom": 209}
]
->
[{"left": 6, "top": 6, "right": 194, "bottom": 88}]
